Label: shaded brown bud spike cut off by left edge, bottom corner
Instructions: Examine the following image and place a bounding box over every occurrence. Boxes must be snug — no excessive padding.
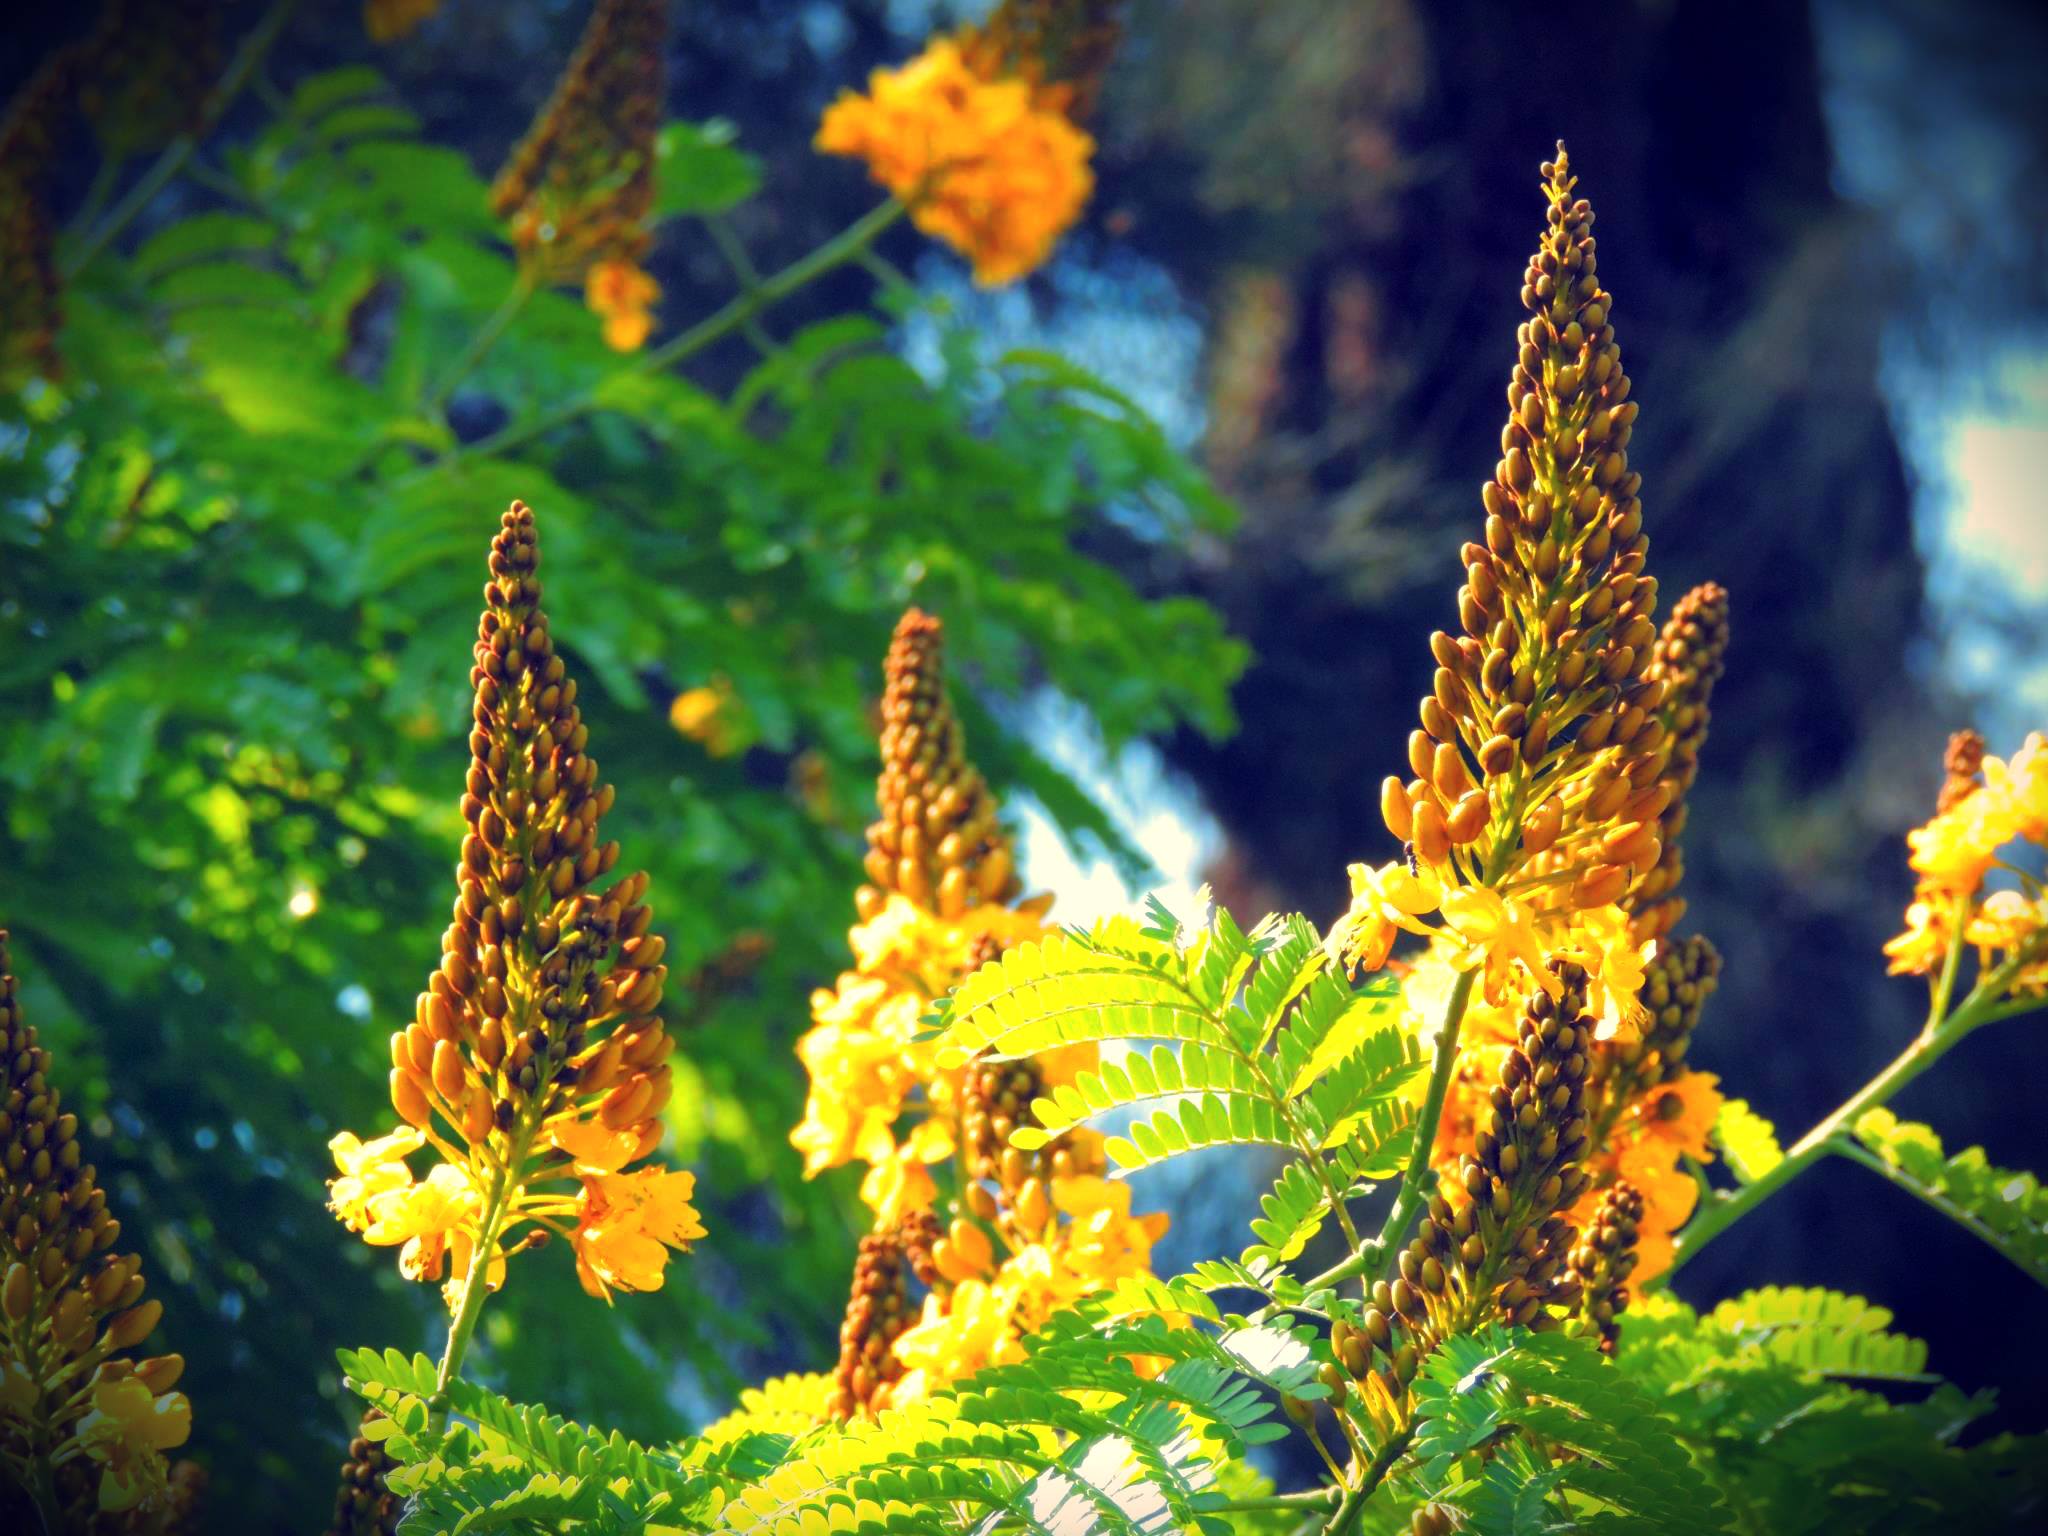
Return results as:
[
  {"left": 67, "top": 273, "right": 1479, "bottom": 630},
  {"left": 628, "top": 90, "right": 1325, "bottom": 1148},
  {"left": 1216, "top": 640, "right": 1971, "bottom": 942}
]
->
[{"left": 0, "top": 930, "right": 193, "bottom": 1513}]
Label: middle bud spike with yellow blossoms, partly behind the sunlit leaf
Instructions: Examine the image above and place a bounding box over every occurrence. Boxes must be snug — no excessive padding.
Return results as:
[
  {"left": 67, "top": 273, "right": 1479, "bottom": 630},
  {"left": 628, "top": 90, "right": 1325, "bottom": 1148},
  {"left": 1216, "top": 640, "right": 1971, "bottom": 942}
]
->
[{"left": 791, "top": 608, "right": 1167, "bottom": 1413}]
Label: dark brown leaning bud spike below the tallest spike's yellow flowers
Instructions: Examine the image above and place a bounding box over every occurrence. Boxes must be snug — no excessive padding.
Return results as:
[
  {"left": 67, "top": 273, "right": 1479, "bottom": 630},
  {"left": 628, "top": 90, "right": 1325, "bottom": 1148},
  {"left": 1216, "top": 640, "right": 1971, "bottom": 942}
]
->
[{"left": 1331, "top": 961, "right": 1593, "bottom": 1413}]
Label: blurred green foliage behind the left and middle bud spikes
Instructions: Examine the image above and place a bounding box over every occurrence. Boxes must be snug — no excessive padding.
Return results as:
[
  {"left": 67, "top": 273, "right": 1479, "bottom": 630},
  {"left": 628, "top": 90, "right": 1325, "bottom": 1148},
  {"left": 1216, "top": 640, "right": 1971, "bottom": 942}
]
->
[{"left": 0, "top": 48, "right": 1241, "bottom": 1528}]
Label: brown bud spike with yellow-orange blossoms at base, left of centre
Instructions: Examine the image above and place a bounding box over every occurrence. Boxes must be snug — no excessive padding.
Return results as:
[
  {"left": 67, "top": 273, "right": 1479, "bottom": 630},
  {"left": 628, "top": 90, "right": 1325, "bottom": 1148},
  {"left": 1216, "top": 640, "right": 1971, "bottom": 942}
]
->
[{"left": 330, "top": 502, "right": 702, "bottom": 1307}]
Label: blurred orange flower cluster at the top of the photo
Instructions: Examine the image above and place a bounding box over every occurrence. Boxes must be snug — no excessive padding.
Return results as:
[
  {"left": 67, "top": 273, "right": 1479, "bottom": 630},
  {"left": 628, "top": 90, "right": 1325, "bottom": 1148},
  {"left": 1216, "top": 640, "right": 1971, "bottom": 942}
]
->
[{"left": 817, "top": 37, "right": 1096, "bottom": 285}]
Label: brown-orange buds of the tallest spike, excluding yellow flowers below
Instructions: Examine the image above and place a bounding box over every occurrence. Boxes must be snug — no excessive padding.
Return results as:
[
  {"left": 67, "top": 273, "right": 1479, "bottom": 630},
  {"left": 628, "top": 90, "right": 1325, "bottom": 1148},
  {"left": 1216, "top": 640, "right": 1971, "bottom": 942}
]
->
[{"left": 1382, "top": 145, "right": 1671, "bottom": 907}]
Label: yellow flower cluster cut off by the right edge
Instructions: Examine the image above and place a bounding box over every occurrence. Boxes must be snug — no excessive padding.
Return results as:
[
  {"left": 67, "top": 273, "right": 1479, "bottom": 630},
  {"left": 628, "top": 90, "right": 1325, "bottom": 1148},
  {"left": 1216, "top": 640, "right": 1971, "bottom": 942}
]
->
[{"left": 1884, "top": 731, "right": 2048, "bottom": 991}]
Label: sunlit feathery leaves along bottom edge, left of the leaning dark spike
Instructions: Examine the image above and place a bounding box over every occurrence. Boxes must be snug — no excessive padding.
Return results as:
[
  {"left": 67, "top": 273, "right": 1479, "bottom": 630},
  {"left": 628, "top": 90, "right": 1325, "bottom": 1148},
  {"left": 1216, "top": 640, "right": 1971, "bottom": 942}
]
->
[{"left": 340, "top": 1303, "right": 1325, "bottom": 1536}]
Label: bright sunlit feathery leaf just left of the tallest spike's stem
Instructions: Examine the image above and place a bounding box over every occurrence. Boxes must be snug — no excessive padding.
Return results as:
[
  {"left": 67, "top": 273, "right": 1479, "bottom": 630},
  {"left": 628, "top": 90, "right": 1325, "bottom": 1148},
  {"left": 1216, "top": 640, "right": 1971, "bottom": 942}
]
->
[{"left": 938, "top": 897, "right": 1423, "bottom": 1264}]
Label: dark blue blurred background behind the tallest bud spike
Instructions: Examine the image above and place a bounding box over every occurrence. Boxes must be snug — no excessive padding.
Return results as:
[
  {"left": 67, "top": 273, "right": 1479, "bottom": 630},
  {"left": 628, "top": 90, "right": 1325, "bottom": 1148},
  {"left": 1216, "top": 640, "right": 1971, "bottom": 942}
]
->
[{"left": 4, "top": 0, "right": 2048, "bottom": 1523}]
